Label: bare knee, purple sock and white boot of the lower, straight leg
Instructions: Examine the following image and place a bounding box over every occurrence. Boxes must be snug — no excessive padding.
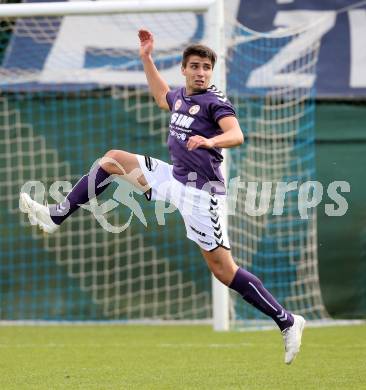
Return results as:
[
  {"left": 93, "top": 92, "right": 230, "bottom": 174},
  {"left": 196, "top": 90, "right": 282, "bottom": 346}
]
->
[{"left": 201, "top": 247, "right": 305, "bottom": 364}]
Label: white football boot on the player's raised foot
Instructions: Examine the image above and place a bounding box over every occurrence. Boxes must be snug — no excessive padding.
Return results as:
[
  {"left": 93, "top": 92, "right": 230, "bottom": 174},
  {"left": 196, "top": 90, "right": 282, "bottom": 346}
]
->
[{"left": 19, "top": 192, "right": 60, "bottom": 233}]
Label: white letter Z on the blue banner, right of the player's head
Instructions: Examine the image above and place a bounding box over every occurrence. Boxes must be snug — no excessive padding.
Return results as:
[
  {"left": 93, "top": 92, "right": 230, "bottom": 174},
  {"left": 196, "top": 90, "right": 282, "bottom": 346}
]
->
[{"left": 247, "top": 10, "right": 336, "bottom": 88}]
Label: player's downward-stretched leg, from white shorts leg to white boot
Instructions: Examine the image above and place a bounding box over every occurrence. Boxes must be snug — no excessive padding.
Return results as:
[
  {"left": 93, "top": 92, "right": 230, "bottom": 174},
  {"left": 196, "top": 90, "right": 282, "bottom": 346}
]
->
[{"left": 176, "top": 184, "right": 305, "bottom": 364}]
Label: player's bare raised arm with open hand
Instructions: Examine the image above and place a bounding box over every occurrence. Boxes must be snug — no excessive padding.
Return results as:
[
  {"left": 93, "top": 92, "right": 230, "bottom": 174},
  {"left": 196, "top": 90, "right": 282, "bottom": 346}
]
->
[{"left": 138, "top": 29, "right": 169, "bottom": 111}]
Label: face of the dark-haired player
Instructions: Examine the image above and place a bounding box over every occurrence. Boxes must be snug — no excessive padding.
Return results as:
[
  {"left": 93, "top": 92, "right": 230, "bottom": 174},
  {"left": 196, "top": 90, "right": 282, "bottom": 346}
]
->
[{"left": 182, "top": 56, "right": 213, "bottom": 95}]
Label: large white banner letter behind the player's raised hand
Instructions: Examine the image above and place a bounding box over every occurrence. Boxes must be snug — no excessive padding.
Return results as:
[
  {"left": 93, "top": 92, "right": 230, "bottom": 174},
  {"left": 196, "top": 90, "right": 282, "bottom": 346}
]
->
[{"left": 37, "top": 5, "right": 197, "bottom": 86}]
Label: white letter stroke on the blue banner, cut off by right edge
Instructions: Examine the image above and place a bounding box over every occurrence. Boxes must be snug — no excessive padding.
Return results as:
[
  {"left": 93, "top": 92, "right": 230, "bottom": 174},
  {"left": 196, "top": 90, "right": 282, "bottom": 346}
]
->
[{"left": 348, "top": 9, "right": 366, "bottom": 88}]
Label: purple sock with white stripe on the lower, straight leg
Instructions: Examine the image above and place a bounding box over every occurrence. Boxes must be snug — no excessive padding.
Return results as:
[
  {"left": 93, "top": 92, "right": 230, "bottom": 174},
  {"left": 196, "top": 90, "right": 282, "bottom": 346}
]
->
[{"left": 229, "top": 268, "right": 294, "bottom": 331}]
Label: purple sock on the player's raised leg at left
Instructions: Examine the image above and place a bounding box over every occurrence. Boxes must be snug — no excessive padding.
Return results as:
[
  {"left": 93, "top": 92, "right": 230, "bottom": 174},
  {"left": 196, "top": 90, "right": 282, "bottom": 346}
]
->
[{"left": 49, "top": 165, "right": 111, "bottom": 225}]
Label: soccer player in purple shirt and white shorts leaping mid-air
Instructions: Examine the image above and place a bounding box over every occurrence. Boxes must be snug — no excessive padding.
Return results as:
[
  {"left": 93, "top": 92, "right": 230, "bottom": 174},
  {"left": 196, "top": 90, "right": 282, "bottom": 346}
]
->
[{"left": 20, "top": 30, "right": 305, "bottom": 364}]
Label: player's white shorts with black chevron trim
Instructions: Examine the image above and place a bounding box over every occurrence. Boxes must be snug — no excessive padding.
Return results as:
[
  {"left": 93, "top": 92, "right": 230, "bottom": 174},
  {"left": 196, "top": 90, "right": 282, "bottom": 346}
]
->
[{"left": 136, "top": 155, "right": 230, "bottom": 251}]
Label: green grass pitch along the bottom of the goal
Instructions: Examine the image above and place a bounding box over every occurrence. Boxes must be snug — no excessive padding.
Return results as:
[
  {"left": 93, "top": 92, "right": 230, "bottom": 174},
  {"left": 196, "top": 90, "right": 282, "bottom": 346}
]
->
[{"left": 0, "top": 325, "right": 366, "bottom": 390}]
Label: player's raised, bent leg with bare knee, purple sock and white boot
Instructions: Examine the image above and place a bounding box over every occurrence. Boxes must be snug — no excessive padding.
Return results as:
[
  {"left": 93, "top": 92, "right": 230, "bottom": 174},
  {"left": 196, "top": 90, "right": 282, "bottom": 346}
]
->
[{"left": 19, "top": 150, "right": 149, "bottom": 233}]
